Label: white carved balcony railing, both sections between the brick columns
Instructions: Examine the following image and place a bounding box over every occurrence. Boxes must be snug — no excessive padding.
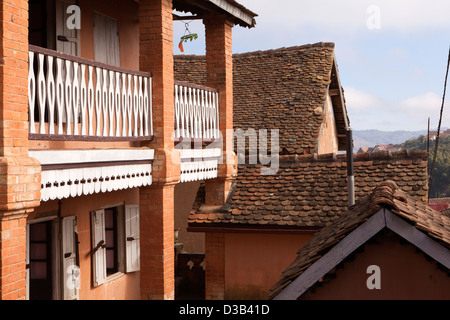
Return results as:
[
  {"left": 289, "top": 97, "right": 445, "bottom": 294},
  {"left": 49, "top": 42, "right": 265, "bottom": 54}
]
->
[{"left": 28, "top": 45, "right": 220, "bottom": 142}]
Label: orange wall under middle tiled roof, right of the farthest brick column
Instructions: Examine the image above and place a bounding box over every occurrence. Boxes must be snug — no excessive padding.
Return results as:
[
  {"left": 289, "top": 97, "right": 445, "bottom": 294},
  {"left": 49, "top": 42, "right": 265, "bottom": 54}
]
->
[{"left": 225, "top": 233, "right": 311, "bottom": 299}]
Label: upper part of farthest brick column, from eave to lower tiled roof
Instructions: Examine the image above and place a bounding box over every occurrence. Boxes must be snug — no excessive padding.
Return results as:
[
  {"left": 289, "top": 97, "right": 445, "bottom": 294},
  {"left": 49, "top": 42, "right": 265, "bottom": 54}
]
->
[{"left": 203, "top": 14, "right": 236, "bottom": 205}]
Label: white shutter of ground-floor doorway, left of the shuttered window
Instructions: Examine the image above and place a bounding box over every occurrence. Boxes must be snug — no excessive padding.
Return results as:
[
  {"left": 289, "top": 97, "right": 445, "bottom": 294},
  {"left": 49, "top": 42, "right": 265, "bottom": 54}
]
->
[{"left": 61, "top": 216, "right": 80, "bottom": 300}]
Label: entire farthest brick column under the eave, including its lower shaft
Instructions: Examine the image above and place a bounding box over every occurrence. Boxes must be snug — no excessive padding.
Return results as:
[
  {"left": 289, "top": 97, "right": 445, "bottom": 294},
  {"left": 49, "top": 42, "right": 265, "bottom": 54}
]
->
[{"left": 203, "top": 14, "right": 236, "bottom": 300}]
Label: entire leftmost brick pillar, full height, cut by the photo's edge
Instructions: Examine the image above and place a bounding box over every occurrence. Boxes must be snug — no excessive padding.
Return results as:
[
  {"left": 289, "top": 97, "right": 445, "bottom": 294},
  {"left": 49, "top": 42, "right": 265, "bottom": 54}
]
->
[{"left": 0, "top": 0, "right": 41, "bottom": 300}]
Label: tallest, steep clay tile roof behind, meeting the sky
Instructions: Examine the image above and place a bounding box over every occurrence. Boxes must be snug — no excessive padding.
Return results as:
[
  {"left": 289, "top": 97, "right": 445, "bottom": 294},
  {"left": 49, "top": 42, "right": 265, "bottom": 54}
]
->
[{"left": 174, "top": 43, "right": 349, "bottom": 154}]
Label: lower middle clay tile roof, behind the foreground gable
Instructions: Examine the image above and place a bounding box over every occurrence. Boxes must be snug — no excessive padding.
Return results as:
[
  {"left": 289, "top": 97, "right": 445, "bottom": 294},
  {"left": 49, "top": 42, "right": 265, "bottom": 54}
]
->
[{"left": 188, "top": 150, "right": 428, "bottom": 229}]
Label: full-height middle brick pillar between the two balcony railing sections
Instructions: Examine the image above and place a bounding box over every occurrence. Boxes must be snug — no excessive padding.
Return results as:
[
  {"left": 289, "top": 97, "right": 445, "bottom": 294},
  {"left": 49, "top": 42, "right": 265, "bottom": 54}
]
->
[{"left": 139, "top": 0, "right": 180, "bottom": 300}]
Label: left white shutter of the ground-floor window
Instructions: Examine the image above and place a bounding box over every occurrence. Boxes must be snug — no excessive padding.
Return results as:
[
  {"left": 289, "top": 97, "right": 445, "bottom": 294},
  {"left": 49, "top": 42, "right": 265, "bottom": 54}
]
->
[{"left": 91, "top": 210, "right": 106, "bottom": 287}]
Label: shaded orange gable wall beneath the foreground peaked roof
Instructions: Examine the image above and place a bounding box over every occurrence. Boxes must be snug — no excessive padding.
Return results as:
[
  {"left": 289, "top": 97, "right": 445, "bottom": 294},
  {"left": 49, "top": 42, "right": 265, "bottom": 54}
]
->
[{"left": 303, "top": 233, "right": 450, "bottom": 300}]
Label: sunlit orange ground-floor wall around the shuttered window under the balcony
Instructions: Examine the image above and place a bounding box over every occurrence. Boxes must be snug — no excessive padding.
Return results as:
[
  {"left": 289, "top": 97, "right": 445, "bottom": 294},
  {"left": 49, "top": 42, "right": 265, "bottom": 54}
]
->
[{"left": 29, "top": 189, "right": 140, "bottom": 300}]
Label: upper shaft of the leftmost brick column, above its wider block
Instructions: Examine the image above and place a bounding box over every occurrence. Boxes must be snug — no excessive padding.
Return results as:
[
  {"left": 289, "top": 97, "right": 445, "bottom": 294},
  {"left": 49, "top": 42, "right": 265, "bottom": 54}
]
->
[{"left": 0, "top": 0, "right": 28, "bottom": 157}]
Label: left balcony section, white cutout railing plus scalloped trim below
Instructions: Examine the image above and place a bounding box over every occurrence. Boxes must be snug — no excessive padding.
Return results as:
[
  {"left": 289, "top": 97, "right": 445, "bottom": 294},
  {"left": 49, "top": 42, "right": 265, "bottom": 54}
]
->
[{"left": 28, "top": 45, "right": 154, "bottom": 201}]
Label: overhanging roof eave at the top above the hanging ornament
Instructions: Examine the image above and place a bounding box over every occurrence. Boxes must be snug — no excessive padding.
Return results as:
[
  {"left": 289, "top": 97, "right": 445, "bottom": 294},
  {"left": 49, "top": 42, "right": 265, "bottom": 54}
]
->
[{"left": 173, "top": 0, "right": 258, "bottom": 28}]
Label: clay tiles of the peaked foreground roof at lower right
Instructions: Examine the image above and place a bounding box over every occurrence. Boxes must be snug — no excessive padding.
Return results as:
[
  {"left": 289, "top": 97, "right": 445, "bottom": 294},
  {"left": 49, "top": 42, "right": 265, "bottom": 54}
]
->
[{"left": 269, "top": 181, "right": 450, "bottom": 298}]
